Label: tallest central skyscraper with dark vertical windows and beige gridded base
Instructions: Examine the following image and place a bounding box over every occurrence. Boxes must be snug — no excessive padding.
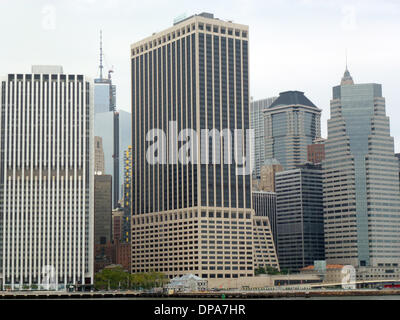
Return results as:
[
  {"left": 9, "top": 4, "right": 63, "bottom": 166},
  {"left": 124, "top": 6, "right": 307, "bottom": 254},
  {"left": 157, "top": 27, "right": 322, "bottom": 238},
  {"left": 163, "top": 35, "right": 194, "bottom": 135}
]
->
[{"left": 131, "top": 13, "right": 276, "bottom": 278}]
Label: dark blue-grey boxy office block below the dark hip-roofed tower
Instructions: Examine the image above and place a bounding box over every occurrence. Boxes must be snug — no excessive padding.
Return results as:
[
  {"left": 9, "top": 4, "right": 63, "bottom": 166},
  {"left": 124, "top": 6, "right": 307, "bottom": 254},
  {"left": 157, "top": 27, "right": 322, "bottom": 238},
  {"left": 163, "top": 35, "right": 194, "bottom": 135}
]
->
[{"left": 276, "top": 164, "right": 325, "bottom": 271}]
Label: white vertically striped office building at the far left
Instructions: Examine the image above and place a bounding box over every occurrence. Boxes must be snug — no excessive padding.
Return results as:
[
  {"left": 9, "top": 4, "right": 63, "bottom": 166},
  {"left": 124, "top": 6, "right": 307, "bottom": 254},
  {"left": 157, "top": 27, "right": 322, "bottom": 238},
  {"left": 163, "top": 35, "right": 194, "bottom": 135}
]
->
[{"left": 0, "top": 66, "right": 94, "bottom": 290}]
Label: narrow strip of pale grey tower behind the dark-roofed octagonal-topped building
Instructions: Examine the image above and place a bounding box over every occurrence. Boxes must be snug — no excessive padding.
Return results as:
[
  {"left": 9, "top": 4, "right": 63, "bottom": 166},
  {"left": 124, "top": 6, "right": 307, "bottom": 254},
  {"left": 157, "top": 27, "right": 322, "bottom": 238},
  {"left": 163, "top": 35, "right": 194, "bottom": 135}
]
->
[{"left": 250, "top": 97, "right": 276, "bottom": 179}]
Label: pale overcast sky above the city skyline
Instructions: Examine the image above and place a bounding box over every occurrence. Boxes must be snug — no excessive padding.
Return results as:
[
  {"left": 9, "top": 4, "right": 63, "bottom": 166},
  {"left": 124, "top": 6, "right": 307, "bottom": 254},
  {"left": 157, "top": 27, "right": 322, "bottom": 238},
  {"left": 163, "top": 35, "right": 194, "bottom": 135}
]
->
[{"left": 0, "top": 0, "right": 400, "bottom": 152}]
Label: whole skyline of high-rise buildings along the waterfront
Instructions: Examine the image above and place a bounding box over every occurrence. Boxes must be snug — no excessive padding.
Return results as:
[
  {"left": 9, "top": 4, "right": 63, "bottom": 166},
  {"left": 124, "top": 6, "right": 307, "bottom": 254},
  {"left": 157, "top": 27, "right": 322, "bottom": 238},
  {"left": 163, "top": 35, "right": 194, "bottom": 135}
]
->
[{"left": 0, "top": 13, "right": 400, "bottom": 290}]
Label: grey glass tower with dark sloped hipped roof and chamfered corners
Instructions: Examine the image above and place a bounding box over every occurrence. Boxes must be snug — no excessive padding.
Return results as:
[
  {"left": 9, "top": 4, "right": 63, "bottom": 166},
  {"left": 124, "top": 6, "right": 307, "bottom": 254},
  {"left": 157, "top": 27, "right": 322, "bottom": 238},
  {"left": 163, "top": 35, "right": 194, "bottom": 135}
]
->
[{"left": 264, "top": 91, "right": 321, "bottom": 170}]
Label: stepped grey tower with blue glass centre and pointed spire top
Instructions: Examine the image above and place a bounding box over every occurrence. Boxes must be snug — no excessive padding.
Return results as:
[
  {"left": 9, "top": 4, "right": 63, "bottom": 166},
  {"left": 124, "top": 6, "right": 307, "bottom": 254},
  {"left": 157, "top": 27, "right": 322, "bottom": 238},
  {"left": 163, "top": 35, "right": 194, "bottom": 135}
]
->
[{"left": 323, "top": 69, "right": 400, "bottom": 268}]
